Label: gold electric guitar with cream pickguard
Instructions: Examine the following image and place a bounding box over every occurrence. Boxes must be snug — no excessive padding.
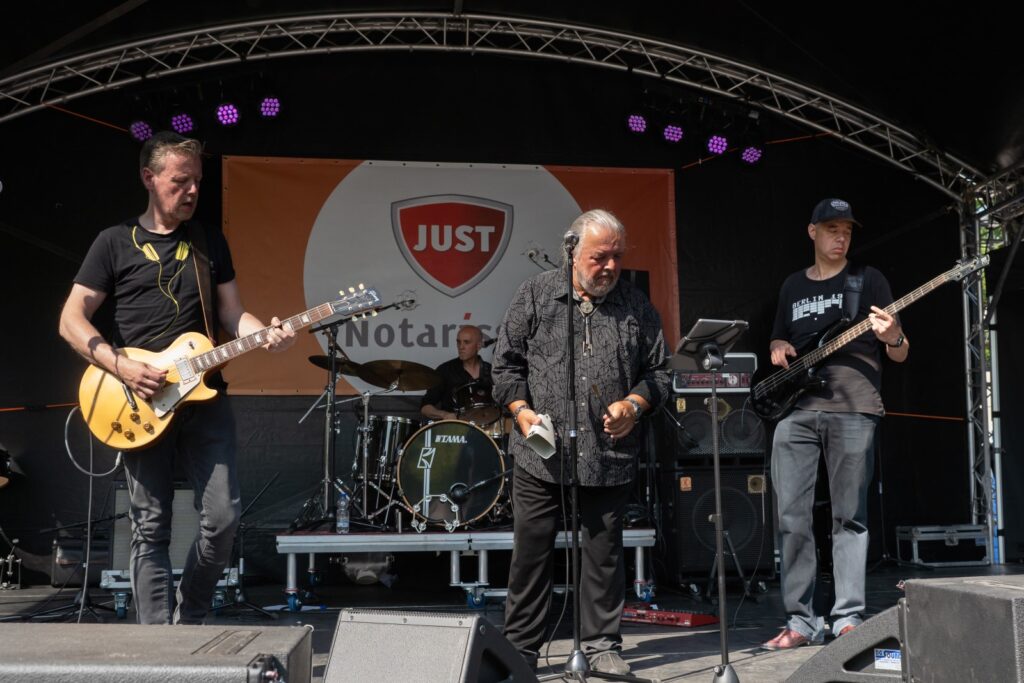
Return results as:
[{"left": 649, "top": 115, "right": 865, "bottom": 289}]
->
[{"left": 78, "top": 285, "right": 381, "bottom": 451}]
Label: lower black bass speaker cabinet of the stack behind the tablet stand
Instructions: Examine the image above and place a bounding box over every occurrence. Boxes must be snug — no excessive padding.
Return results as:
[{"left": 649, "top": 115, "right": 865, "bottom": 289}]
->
[{"left": 669, "top": 467, "right": 775, "bottom": 578}]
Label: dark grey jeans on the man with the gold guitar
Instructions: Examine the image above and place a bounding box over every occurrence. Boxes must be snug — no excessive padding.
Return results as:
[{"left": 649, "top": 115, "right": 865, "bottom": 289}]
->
[{"left": 124, "top": 396, "right": 241, "bottom": 624}]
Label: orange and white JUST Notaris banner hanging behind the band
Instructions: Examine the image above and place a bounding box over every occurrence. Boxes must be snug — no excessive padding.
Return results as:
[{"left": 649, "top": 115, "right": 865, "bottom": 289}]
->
[{"left": 223, "top": 157, "right": 679, "bottom": 394}]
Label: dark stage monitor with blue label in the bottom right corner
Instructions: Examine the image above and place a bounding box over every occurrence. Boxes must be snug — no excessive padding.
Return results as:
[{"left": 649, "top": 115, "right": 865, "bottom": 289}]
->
[{"left": 788, "top": 574, "right": 1024, "bottom": 683}]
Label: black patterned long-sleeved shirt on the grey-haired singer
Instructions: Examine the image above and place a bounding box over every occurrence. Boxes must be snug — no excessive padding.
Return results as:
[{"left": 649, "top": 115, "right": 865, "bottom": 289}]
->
[{"left": 492, "top": 270, "right": 670, "bottom": 486}]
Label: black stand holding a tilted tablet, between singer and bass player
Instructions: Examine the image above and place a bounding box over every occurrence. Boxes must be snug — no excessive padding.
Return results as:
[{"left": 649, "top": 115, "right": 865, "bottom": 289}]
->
[{"left": 669, "top": 318, "right": 748, "bottom": 683}]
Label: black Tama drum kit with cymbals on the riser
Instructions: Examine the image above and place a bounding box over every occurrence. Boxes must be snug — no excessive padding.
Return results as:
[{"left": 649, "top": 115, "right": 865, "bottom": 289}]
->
[{"left": 301, "top": 355, "right": 513, "bottom": 531}]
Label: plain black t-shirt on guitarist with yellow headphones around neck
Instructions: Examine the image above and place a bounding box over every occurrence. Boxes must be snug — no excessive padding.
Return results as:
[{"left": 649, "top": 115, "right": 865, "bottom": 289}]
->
[{"left": 75, "top": 220, "right": 234, "bottom": 351}]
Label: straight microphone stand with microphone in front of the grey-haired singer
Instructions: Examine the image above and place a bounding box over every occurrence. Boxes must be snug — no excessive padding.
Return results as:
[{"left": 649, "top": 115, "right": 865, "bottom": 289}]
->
[{"left": 540, "top": 232, "right": 651, "bottom": 683}]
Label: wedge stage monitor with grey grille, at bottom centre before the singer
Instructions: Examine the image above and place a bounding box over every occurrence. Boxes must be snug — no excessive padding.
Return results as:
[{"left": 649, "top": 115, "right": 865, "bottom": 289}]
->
[{"left": 324, "top": 609, "right": 537, "bottom": 683}]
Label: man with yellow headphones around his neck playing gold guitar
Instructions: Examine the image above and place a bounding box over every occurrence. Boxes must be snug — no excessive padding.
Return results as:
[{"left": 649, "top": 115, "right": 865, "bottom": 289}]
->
[{"left": 60, "top": 132, "right": 295, "bottom": 624}]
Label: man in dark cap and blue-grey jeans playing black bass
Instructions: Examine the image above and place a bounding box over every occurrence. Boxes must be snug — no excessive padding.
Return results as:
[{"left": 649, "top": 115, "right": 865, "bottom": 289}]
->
[{"left": 764, "top": 199, "right": 909, "bottom": 650}]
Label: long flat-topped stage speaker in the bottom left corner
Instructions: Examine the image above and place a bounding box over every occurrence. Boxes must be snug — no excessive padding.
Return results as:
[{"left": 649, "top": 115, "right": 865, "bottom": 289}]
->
[{"left": 0, "top": 624, "right": 313, "bottom": 683}]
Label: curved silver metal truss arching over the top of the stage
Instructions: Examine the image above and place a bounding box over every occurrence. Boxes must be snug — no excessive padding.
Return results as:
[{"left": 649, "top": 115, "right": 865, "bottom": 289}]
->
[{"left": 6, "top": 12, "right": 981, "bottom": 201}]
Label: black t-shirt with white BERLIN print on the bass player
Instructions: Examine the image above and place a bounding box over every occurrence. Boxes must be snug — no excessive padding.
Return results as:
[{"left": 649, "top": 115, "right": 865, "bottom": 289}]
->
[{"left": 771, "top": 263, "right": 893, "bottom": 415}]
